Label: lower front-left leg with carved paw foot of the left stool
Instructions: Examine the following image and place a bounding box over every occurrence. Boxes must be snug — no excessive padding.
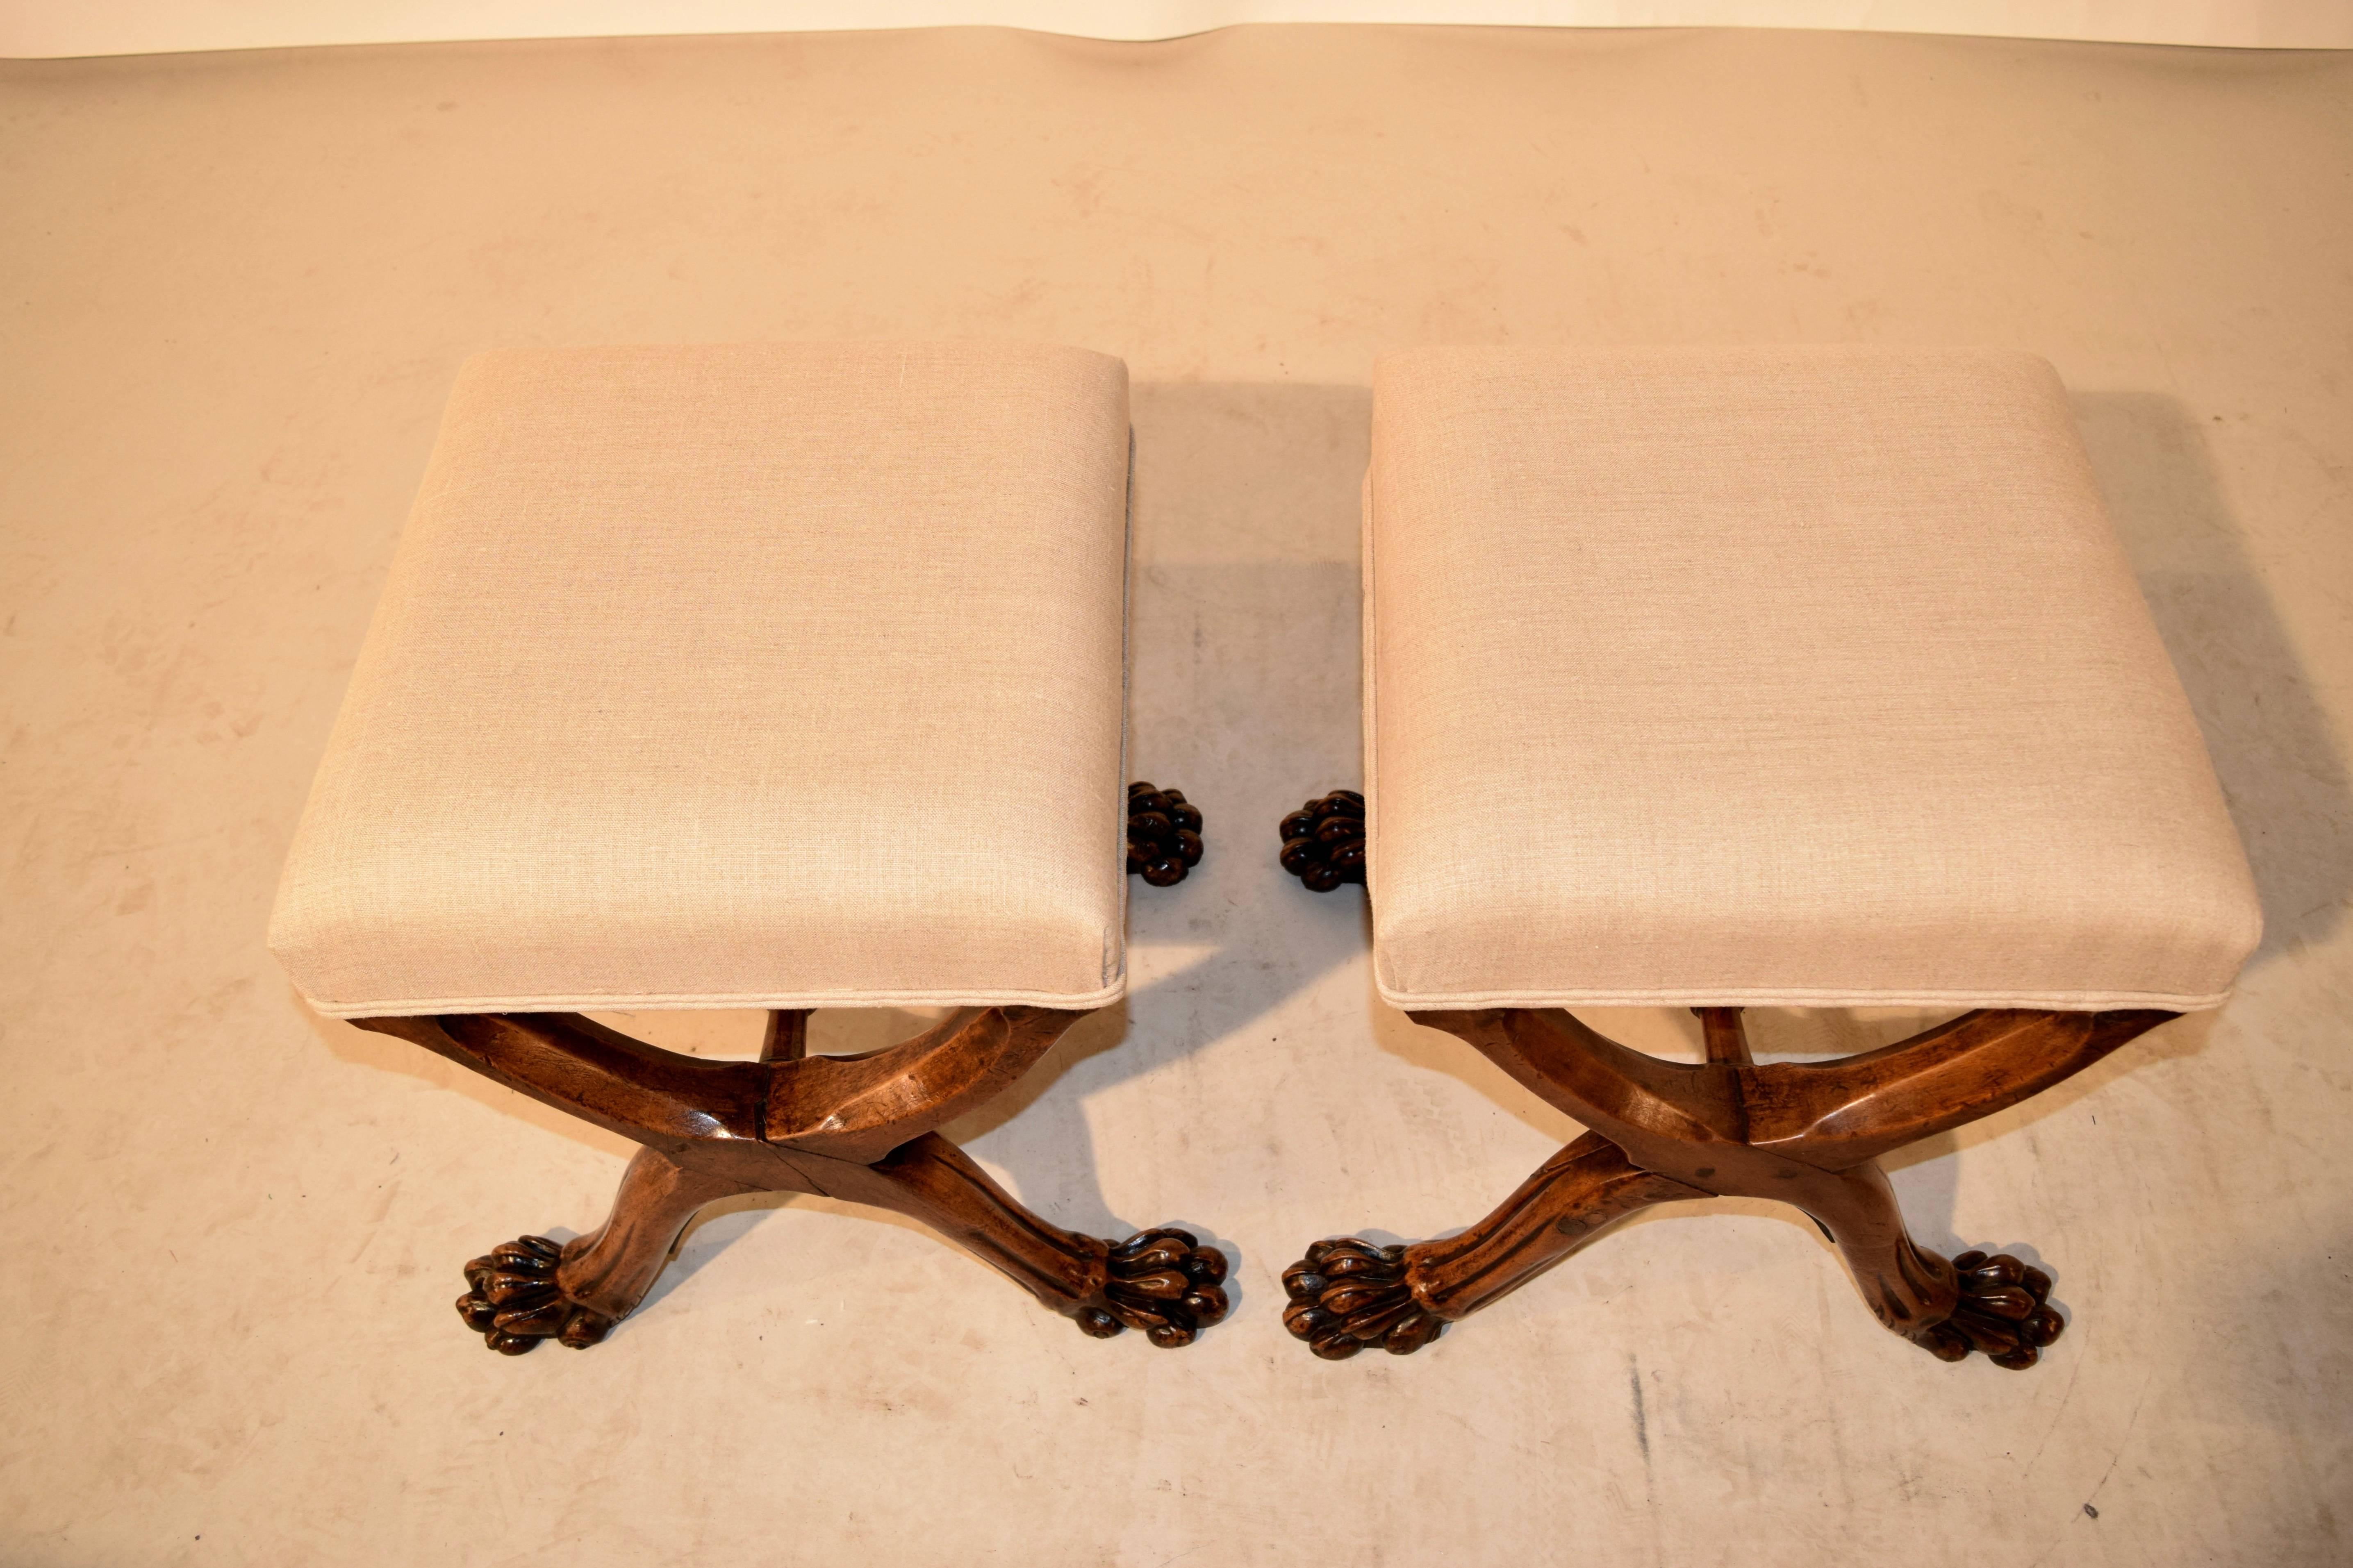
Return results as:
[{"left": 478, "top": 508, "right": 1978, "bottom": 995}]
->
[{"left": 457, "top": 1147, "right": 760, "bottom": 1357}]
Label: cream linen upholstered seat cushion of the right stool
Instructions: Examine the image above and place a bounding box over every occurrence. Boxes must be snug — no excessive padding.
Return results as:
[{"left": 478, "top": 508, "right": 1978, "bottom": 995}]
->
[{"left": 1365, "top": 348, "right": 2259, "bottom": 1009}]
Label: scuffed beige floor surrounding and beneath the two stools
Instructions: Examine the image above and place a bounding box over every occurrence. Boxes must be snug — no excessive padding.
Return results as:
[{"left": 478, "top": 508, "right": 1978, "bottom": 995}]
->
[{"left": 0, "top": 28, "right": 2353, "bottom": 1568}]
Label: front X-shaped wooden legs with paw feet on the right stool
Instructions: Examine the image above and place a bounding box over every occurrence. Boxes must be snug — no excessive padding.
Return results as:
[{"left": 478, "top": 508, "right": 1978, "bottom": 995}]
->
[{"left": 1282, "top": 1009, "right": 2172, "bottom": 1368}]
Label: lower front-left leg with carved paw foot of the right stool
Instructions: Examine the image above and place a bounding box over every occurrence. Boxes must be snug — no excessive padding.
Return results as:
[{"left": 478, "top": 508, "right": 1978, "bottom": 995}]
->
[{"left": 1282, "top": 1133, "right": 1708, "bottom": 1361}]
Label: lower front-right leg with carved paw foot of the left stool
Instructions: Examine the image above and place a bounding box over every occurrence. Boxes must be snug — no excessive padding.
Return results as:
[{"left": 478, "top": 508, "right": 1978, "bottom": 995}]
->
[{"left": 802, "top": 1133, "right": 1226, "bottom": 1350}]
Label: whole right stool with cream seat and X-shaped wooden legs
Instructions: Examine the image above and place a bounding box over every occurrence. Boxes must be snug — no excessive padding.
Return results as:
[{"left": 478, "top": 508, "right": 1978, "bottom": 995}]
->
[{"left": 1282, "top": 348, "right": 2259, "bottom": 1368}]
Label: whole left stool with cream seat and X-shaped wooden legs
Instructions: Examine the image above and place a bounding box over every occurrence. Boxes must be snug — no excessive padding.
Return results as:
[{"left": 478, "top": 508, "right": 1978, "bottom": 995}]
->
[{"left": 271, "top": 343, "right": 1226, "bottom": 1352}]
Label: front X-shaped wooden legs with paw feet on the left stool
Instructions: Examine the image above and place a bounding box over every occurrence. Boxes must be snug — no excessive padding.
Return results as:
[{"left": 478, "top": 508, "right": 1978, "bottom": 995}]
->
[{"left": 353, "top": 1006, "right": 1226, "bottom": 1354}]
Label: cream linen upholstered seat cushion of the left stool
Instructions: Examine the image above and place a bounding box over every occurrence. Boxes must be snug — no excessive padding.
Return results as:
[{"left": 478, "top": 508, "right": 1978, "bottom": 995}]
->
[{"left": 271, "top": 343, "right": 1127, "bottom": 1018}]
